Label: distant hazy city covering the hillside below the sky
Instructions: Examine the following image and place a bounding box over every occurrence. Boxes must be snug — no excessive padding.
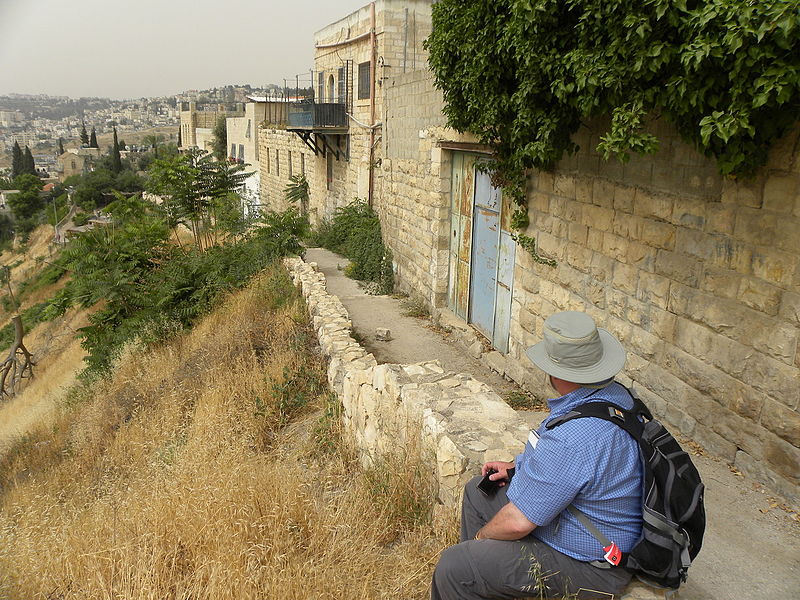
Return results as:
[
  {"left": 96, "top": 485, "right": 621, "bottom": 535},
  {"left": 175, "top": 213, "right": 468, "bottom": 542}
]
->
[{"left": 0, "top": 84, "right": 280, "bottom": 174}]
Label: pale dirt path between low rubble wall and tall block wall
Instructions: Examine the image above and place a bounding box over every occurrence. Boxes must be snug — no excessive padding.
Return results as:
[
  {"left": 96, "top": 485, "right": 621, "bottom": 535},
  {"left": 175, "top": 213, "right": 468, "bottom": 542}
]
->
[{"left": 306, "top": 248, "right": 800, "bottom": 600}]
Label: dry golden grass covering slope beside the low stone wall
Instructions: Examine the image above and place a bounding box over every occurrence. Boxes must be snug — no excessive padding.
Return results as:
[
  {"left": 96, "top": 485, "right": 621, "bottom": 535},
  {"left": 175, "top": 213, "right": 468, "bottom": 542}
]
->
[{"left": 0, "top": 267, "right": 455, "bottom": 600}]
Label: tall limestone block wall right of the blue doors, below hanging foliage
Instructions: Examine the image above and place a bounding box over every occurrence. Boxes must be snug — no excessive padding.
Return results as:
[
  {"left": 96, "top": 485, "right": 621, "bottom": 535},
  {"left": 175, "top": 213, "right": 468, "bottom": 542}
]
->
[{"left": 499, "top": 124, "right": 800, "bottom": 500}]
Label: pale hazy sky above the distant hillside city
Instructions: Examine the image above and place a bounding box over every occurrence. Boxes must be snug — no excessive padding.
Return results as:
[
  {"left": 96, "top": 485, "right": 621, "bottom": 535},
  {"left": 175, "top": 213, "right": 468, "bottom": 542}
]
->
[{"left": 0, "top": 0, "right": 369, "bottom": 98}]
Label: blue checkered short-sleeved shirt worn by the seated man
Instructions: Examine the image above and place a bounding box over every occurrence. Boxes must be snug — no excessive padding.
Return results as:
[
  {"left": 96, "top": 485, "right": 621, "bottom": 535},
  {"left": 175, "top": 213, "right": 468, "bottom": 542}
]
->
[{"left": 508, "top": 383, "right": 642, "bottom": 561}]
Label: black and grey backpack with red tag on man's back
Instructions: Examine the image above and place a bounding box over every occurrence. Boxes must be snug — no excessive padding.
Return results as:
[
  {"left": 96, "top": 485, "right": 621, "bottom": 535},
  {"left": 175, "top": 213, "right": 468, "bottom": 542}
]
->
[{"left": 546, "top": 388, "right": 706, "bottom": 589}]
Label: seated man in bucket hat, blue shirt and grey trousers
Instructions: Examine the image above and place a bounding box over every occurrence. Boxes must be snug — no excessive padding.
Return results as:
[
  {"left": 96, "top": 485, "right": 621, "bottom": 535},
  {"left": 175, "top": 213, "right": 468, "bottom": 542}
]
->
[{"left": 431, "top": 311, "right": 642, "bottom": 600}]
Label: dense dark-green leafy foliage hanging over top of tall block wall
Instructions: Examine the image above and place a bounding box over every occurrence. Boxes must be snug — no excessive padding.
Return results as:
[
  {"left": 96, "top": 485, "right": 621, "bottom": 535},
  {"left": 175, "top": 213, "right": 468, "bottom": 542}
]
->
[{"left": 426, "top": 0, "right": 800, "bottom": 178}]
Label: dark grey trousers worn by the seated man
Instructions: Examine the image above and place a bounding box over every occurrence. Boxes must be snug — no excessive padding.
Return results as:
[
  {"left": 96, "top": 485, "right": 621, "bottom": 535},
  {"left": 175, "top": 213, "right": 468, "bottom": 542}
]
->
[{"left": 431, "top": 477, "right": 631, "bottom": 600}]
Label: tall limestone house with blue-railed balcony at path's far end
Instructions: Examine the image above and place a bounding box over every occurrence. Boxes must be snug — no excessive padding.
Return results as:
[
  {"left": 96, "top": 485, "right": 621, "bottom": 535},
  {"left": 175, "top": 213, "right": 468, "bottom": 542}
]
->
[{"left": 259, "top": 0, "right": 431, "bottom": 223}]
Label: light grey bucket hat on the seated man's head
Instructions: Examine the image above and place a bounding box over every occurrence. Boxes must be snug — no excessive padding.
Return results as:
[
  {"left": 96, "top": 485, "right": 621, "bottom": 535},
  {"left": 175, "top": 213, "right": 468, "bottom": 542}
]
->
[{"left": 525, "top": 311, "right": 625, "bottom": 383}]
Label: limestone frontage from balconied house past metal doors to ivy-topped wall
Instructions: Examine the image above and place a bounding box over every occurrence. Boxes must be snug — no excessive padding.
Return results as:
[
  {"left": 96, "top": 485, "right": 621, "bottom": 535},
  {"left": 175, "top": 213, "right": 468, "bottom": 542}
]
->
[{"left": 259, "top": 0, "right": 800, "bottom": 500}]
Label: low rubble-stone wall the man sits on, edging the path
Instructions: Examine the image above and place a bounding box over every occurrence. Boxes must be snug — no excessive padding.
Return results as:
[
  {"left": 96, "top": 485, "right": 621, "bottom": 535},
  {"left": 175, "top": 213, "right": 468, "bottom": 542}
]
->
[{"left": 285, "top": 258, "right": 528, "bottom": 506}]
